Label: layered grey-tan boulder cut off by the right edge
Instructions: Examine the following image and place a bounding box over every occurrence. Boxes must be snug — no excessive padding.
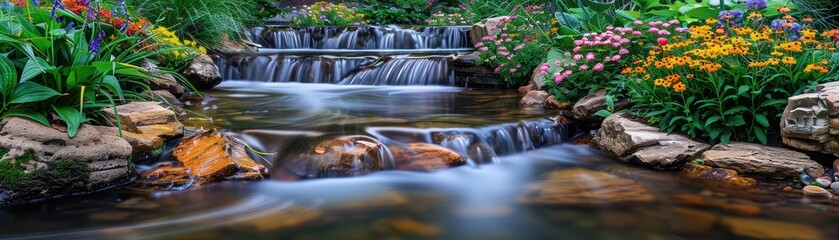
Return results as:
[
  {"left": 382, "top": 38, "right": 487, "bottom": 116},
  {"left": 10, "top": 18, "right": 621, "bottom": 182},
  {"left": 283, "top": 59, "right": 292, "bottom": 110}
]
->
[{"left": 781, "top": 82, "right": 839, "bottom": 156}]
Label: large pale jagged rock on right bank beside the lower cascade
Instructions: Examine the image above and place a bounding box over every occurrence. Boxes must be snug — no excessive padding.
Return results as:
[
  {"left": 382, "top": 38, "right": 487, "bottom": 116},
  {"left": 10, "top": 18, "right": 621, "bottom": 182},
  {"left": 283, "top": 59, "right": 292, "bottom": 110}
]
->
[{"left": 591, "top": 114, "right": 710, "bottom": 168}]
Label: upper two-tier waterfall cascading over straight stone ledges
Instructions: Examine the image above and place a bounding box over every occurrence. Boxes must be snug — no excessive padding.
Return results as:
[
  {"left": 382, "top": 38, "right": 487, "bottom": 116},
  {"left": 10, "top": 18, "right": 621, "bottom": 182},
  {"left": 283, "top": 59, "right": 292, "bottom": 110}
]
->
[{"left": 216, "top": 26, "right": 472, "bottom": 86}]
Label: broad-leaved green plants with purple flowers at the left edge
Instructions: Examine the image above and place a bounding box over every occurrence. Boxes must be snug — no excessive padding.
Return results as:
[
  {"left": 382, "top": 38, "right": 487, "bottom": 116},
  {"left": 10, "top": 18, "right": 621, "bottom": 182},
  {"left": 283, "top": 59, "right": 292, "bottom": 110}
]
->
[{"left": 0, "top": 1, "right": 156, "bottom": 137}]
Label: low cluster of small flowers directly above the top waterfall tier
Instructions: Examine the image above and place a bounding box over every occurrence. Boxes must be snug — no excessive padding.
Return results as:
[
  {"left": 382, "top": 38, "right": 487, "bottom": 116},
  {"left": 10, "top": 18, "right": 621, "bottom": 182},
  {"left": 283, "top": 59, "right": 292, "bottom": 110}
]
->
[{"left": 290, "top": 1, "right": 367, "bottom": 26}]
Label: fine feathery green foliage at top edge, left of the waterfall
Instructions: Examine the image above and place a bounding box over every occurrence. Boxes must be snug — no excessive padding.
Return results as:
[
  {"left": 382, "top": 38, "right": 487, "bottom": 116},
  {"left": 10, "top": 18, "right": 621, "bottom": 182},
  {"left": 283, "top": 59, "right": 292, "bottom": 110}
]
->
[{"left": 140, "top": 0, "right": 259, "bottom": 48}]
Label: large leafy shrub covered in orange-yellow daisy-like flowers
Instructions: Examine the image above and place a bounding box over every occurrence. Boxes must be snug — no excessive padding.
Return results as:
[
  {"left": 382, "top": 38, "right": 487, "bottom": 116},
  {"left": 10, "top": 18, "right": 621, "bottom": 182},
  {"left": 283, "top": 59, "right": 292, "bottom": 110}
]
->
[{"left": 623, "top": 8, "right": 839, "bottom": 144}]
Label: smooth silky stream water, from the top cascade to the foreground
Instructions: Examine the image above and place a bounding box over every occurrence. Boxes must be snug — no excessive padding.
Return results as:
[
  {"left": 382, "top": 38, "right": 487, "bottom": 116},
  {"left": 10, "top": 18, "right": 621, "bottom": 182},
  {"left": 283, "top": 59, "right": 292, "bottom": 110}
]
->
[{"left": 0, "top": 27, "right": 839, "bottom": 239}]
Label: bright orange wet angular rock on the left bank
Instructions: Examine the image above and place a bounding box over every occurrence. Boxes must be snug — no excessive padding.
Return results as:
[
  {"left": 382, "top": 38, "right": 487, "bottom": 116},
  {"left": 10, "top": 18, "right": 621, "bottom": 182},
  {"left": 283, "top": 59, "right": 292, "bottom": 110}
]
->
[{"left": 172, "top": 130, "right": 266, "bottom": 184}]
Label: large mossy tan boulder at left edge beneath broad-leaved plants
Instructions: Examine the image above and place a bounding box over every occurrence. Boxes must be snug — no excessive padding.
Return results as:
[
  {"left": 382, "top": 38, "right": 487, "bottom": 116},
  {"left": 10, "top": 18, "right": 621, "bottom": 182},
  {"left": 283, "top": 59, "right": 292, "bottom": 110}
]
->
[{"left": 0, "top": 117, "right": 136, "bottom": 205}]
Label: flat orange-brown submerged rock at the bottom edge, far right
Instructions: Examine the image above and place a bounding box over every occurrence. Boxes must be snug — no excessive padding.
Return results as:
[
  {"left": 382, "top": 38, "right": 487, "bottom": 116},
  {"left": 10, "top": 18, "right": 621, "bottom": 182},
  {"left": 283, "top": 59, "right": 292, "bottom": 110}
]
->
[{"left": 720, "top": 217, "right": 823, "bottom": 240}]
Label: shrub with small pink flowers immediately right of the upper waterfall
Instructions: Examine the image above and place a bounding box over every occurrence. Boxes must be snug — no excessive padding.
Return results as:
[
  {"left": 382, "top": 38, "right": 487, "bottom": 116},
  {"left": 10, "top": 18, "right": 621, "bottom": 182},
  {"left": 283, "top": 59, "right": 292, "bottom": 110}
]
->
[{"left": 475, "top": 5, "right": 558, "bottom": 85}]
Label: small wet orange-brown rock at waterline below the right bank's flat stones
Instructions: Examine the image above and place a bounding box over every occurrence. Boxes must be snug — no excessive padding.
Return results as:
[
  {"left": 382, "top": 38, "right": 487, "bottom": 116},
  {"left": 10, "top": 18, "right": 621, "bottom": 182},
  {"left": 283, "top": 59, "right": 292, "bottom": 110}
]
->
[{"left": 679, "top": 163, "right": 757, "bottom": 188}]
